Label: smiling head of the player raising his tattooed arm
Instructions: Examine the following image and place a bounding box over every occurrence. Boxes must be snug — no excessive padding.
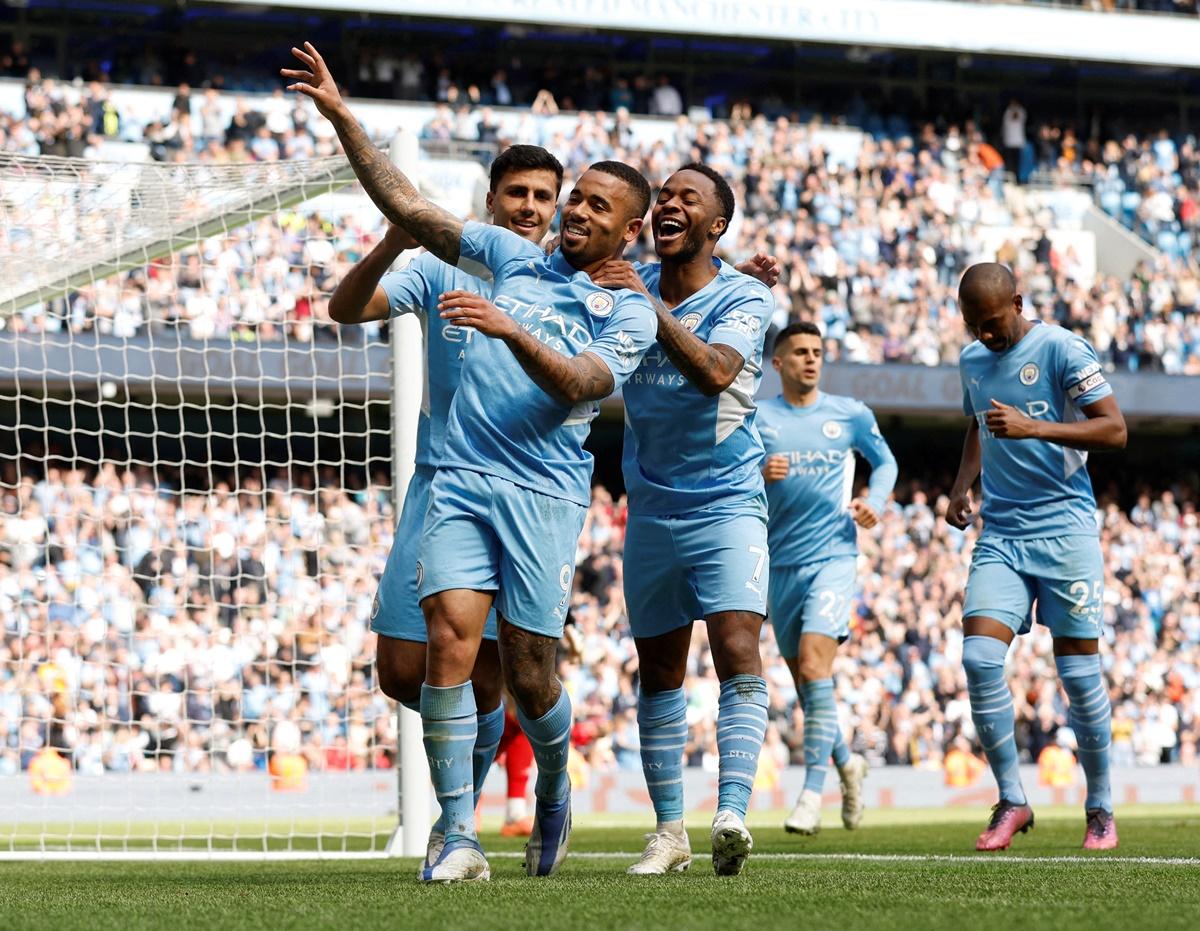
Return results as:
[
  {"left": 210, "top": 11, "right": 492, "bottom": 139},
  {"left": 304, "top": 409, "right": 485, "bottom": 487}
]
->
[{"left": 560, "top": 169, "right": 642, "bottom": 269}]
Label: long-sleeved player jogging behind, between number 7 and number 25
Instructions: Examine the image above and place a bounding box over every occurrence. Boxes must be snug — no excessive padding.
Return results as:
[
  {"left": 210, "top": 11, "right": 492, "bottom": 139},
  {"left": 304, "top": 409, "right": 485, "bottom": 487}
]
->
[{"left": 758, "top": 323, "right": 898, "bottom": 834}]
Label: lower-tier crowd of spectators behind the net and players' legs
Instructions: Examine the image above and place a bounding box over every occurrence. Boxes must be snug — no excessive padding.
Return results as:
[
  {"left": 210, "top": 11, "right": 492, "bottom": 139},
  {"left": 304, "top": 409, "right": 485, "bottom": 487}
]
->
[{"left": 0, "top": 463, "right": 1200, "bottom": 775}]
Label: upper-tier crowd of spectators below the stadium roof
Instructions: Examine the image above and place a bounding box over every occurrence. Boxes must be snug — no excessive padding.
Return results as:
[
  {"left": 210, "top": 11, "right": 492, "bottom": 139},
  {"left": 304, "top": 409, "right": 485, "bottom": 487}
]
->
[{"left": 7, "top": 71, "right": 1200, "bottom": 374}]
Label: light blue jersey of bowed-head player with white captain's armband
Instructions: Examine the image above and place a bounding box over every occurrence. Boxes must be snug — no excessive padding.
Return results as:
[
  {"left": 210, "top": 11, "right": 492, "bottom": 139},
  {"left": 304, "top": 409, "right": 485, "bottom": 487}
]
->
[{"left": 959, "top": 322, "right": 1112, "bottom": 539}]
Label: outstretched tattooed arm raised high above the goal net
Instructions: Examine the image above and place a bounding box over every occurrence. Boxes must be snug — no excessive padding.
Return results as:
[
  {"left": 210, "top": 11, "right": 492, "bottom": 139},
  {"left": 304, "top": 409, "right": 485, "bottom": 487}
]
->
[{"left": 280, "top": 42, "right": 462, "bottom": 265}]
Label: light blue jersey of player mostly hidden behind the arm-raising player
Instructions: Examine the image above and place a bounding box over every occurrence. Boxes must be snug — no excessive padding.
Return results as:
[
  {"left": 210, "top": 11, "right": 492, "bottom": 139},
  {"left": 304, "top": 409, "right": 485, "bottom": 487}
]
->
[{"left": 379, "top": 252, "right": 482, "bottom": 477}]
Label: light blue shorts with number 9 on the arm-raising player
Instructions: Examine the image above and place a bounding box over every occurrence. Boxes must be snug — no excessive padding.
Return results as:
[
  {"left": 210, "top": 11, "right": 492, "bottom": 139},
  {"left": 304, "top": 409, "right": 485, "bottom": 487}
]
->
[{"left": 416, "top": 469, "right": 587, "bottom": 638}]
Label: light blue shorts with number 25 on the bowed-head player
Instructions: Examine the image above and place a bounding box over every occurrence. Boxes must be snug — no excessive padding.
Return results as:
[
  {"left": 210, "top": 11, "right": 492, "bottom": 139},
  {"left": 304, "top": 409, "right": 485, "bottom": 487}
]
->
[{"left": 962, "top": 534, "right": 1104, "bottom": 639}]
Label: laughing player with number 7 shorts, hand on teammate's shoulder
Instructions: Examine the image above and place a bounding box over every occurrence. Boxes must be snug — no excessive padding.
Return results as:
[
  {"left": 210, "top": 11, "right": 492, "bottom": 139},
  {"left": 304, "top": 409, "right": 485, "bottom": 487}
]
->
[{"left": 593, "top": 164, "right": 774, "bottom": 876}]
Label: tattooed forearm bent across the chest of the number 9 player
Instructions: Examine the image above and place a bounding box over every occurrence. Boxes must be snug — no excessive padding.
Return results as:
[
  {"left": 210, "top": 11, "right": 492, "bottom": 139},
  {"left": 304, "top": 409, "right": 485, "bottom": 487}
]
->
[{"left": 438, "top": 290, "right": 616, "bottom": 406}]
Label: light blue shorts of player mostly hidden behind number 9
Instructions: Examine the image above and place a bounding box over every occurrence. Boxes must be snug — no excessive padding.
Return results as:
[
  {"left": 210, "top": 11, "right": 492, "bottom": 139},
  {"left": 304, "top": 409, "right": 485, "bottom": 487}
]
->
[{"left": 371, "top": 470, "right": 496, "bottom": 643}]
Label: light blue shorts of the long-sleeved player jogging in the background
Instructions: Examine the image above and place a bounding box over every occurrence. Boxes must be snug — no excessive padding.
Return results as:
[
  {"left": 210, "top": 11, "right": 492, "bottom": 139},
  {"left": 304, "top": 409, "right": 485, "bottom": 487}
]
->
[{"left": 770, "top": 555, "right": 858, "bottom": 660}]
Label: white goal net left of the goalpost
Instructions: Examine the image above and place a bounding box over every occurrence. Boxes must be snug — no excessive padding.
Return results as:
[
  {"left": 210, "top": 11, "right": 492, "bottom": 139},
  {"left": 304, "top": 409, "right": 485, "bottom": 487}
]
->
[{"left": 0, "top": 149, "right": 417, "bottom": 855}]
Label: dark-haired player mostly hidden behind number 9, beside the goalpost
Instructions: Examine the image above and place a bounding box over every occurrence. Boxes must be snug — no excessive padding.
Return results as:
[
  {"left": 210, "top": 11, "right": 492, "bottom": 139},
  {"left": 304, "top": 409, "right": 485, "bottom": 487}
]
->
[{"left": 319, "top": 145, "right": 563, "bottom": 865}]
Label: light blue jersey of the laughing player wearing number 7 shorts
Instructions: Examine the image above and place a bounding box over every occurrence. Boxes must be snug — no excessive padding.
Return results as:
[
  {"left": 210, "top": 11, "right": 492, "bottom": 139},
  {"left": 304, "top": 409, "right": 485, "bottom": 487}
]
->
[{"left": 622, "top": 262, "right": 775, "bottom": 517}]
